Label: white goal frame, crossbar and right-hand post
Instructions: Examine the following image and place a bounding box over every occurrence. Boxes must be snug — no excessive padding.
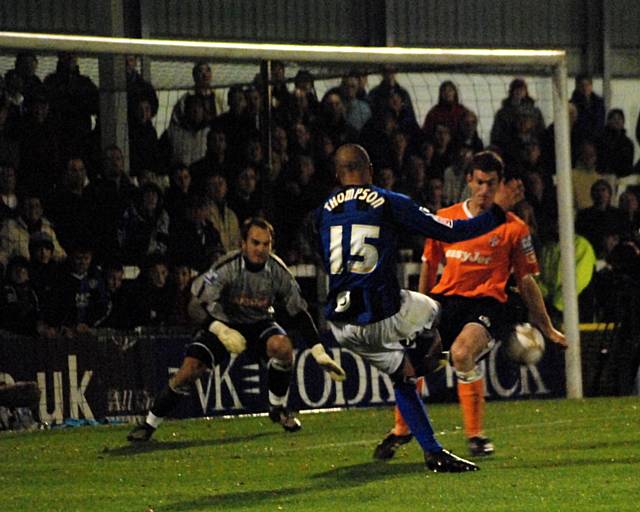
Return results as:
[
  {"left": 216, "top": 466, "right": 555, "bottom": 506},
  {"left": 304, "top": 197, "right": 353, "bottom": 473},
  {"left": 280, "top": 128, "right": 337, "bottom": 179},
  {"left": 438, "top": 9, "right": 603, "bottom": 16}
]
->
[{"left": 0, "top": 32, "right": 583, "bottom": 398}]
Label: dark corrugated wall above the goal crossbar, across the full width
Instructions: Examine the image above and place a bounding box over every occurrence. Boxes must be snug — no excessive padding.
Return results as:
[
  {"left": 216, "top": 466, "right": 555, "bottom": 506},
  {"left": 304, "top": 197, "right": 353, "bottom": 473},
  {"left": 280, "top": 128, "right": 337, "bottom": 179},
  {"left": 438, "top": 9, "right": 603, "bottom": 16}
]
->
[{"left": 0, "top": 0, "right": 640, "bottom": 58}]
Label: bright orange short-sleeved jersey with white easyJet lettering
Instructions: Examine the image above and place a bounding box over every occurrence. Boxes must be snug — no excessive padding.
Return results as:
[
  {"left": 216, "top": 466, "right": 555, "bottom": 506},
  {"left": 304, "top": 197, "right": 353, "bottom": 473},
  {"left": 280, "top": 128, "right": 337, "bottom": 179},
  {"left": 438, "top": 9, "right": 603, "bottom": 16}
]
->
[{"left": 422, "top": 201, "right": 539, "bottom": 302}]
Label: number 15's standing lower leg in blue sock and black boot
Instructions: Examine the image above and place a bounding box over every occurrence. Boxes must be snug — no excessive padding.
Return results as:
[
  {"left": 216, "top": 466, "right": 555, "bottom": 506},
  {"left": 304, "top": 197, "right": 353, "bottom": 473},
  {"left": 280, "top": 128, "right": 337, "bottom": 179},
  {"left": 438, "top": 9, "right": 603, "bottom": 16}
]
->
[{"left": 394, "top": 379, "right": 480, "bottom": 473}]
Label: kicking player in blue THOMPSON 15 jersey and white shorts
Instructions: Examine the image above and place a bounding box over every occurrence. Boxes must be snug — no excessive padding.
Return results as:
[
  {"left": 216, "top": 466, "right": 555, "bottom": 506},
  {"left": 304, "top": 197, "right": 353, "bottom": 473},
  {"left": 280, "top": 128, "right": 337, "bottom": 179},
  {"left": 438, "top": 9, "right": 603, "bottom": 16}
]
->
[{"left": 315, "top": 144, "right": 511, "bottom": 473}]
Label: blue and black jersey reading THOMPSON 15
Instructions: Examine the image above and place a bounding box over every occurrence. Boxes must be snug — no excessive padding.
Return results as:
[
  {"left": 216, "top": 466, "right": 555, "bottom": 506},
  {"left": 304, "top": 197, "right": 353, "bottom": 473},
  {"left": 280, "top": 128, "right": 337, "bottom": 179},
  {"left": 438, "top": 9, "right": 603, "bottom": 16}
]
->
[{"left": 315, "top": 185, "right": 505, "bottom": 325}]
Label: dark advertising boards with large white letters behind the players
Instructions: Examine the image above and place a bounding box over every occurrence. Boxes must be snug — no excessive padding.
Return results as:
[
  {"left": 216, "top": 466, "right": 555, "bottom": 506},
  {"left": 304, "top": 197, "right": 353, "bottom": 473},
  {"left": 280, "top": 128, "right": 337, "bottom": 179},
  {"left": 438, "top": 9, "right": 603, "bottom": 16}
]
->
[{"left": 0, "top": 329, "right": 565, "bottom": 425}]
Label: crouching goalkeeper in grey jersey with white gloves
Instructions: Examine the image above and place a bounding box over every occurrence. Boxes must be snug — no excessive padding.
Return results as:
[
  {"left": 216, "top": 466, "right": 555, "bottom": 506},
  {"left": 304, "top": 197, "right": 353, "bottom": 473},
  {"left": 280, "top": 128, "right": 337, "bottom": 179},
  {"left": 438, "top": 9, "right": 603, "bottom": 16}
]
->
[{"left": 127, "top": 218, "right": 345, "bottom": 442}]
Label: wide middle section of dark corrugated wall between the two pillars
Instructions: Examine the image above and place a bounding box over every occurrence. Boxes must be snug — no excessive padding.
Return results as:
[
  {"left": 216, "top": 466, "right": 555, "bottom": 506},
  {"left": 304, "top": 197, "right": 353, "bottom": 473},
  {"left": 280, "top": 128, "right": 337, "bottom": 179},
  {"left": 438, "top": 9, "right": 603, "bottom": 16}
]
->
[{"left": 141, "top": 0, "right": 592, "bottom": 47}]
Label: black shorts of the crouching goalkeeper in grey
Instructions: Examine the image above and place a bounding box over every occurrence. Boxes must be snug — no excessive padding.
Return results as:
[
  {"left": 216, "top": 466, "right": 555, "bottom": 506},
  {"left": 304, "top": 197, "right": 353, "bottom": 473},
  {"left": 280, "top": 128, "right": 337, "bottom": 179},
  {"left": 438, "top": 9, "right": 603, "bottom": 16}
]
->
[{"left": 186, "top": 320, "right": 287, "bottom": 368}]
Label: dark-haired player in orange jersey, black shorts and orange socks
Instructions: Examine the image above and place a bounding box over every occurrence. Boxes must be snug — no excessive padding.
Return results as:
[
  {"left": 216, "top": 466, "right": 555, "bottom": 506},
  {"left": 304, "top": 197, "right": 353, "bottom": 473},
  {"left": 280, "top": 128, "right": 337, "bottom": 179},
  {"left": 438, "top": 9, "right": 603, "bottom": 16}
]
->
[{"left": 374, "top": 151, "right": 567, "bottom": 459}]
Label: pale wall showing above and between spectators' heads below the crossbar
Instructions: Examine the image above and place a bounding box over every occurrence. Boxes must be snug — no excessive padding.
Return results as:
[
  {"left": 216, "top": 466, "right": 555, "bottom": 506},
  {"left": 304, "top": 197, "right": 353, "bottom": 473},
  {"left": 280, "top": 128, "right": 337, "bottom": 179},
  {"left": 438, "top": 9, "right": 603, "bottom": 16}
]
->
[{"left": 0, "top": 52, "right": 640, "bottom": 155}]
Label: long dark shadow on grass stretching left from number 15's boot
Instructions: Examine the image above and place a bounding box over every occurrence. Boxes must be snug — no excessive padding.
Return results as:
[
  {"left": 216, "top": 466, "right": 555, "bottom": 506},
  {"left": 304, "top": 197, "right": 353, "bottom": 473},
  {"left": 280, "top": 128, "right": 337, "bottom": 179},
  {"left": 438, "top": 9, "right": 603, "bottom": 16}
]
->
[{"left": 154, "top": 462, "right": 425, "bottom": 512}]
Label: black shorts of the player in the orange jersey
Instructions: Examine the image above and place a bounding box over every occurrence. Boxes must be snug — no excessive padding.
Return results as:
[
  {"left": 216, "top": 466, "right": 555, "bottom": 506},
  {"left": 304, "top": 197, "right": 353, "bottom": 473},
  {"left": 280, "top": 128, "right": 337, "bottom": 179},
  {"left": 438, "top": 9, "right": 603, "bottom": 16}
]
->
[{"left": 433, "top": 295, "right": 517, "bottom": 350}]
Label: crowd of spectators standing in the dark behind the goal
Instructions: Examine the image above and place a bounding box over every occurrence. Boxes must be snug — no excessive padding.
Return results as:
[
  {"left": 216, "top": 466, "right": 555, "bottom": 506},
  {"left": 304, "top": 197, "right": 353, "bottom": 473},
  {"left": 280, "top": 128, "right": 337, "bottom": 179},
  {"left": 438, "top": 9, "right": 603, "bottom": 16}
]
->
[{"left": 0, "top": 52, "right": 640, "bottom": 337}]
